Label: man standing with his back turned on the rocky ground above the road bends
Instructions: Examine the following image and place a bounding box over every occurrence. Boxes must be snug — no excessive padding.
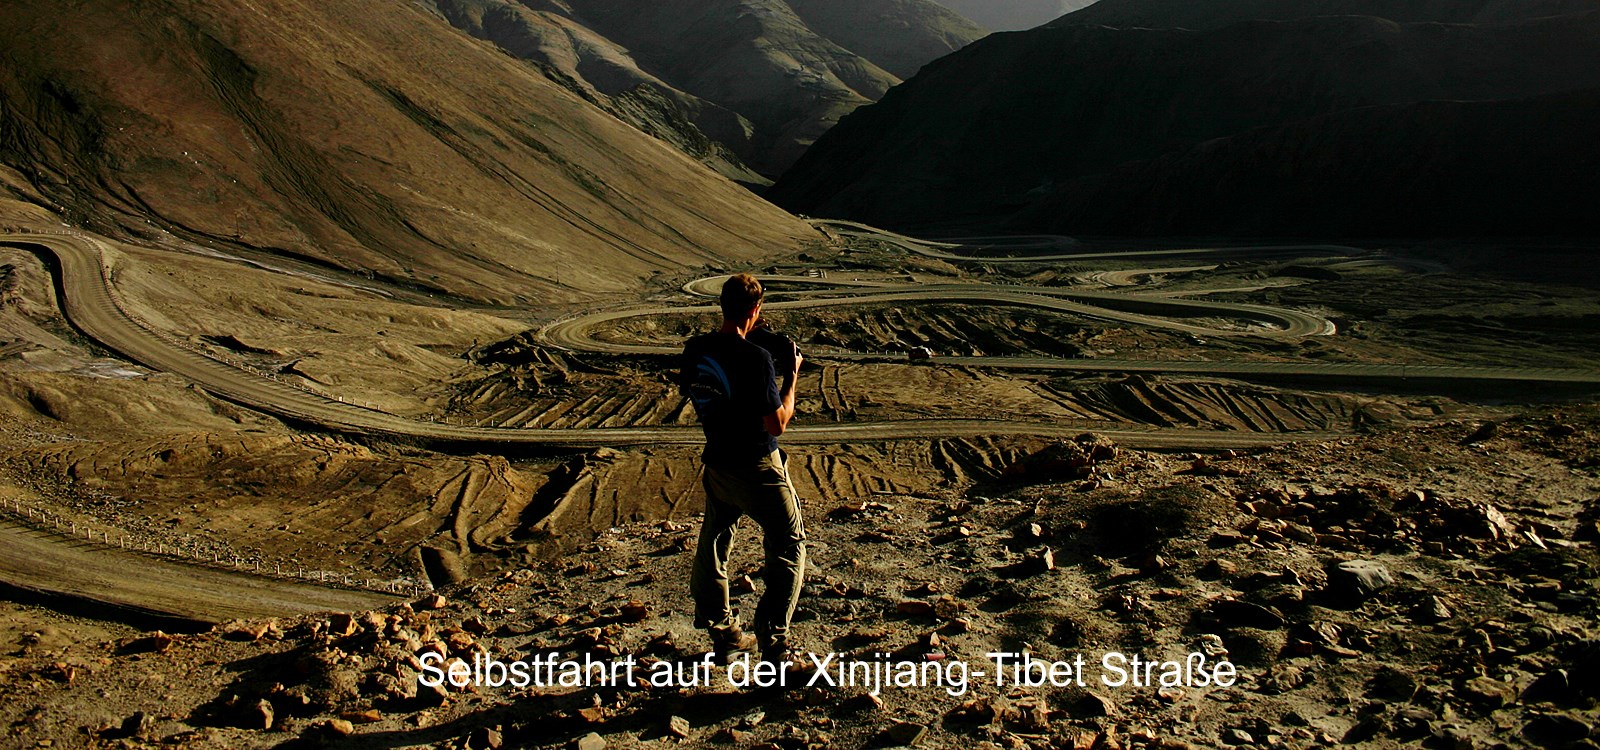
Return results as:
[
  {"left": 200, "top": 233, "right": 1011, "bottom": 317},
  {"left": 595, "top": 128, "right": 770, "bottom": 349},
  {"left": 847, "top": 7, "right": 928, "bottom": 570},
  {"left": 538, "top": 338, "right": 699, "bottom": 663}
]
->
[{"left": 678, "top": 273, "right": 805, "bottom": 662}]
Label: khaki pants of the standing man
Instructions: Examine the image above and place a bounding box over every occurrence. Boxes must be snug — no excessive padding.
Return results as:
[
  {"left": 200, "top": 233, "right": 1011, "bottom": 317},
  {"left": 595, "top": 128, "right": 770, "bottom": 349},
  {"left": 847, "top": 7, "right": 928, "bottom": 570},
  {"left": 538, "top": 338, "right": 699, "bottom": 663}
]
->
[{"left": 690, "top": 451, "right": 805, "bottom": 648}]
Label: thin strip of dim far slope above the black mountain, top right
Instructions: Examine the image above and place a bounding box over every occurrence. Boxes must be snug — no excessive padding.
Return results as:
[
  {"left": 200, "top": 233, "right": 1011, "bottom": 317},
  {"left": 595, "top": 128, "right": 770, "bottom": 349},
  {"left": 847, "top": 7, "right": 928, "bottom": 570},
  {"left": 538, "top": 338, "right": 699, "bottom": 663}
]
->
[{"left": 1050, "top": 0, "right": 1600, "bottom": 29}]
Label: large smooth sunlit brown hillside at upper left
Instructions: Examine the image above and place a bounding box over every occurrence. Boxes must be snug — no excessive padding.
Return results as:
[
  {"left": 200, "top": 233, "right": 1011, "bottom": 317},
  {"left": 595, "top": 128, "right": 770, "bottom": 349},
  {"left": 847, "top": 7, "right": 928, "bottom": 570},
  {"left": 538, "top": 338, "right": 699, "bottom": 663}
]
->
[{"left": 0, "top": 0, "right": 811, "bottom": 302}]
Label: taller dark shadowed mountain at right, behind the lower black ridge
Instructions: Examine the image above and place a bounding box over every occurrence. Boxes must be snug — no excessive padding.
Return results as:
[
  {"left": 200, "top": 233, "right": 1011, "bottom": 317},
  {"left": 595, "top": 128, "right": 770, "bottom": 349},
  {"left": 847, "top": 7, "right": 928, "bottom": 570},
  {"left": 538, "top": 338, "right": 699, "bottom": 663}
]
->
[{"left": 770, "top": 14, "right": 1600, "bottom": 233}]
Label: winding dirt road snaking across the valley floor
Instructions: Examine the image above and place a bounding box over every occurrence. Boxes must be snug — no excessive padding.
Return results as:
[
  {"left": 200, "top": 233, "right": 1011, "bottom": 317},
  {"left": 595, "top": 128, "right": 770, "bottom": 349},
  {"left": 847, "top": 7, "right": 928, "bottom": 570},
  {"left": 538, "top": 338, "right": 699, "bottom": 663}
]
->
[{"left": 0, "top": 215, "right": 1600, "bottom": 620}]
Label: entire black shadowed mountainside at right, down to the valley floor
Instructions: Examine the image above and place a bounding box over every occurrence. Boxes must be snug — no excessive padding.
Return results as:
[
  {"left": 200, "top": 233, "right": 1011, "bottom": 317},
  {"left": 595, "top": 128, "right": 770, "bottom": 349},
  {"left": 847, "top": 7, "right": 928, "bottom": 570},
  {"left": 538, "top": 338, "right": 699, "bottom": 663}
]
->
[{"left": 771, "top": 13, "right": 1600, "bottom": 235}]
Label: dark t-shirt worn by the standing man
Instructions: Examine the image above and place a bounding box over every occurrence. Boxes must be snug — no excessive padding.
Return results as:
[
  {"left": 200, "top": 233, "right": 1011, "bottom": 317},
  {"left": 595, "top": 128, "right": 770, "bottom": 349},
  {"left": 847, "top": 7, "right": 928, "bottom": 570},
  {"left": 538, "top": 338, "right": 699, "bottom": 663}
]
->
[{"left": 678, "top": 331, "right": 782, "bottom": 469}]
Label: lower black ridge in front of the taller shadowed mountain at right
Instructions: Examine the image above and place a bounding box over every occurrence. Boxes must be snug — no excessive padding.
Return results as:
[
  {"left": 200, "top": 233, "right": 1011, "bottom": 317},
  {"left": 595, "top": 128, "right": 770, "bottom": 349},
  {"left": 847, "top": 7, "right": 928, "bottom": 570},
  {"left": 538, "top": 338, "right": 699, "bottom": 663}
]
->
[{"left": 1011, "top": 90, "right": 1600, "bottom": 237}]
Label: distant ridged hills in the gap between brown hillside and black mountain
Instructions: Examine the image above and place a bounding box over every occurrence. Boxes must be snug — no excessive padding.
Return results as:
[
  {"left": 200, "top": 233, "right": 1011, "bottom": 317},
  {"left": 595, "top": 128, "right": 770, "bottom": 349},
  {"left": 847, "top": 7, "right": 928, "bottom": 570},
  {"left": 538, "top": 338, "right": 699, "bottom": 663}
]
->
[{"left": 430, "top": 0, "right": 984, "bottom": 176}]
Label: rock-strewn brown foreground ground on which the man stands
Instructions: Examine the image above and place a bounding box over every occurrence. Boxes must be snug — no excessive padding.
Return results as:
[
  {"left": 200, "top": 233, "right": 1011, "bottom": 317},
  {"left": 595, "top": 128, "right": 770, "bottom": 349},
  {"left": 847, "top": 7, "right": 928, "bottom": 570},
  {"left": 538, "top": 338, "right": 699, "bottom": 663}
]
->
[{"left": 0, "top": 408, "right": 1600, "bottom": 747}]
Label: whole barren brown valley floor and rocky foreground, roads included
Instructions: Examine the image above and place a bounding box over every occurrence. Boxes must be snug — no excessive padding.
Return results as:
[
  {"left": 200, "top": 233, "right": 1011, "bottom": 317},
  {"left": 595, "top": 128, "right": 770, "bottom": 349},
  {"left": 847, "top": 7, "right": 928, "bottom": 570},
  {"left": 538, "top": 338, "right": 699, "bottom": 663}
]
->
[{"left": 0, "top": 197, "right": 1600, "bottom": 747}]
